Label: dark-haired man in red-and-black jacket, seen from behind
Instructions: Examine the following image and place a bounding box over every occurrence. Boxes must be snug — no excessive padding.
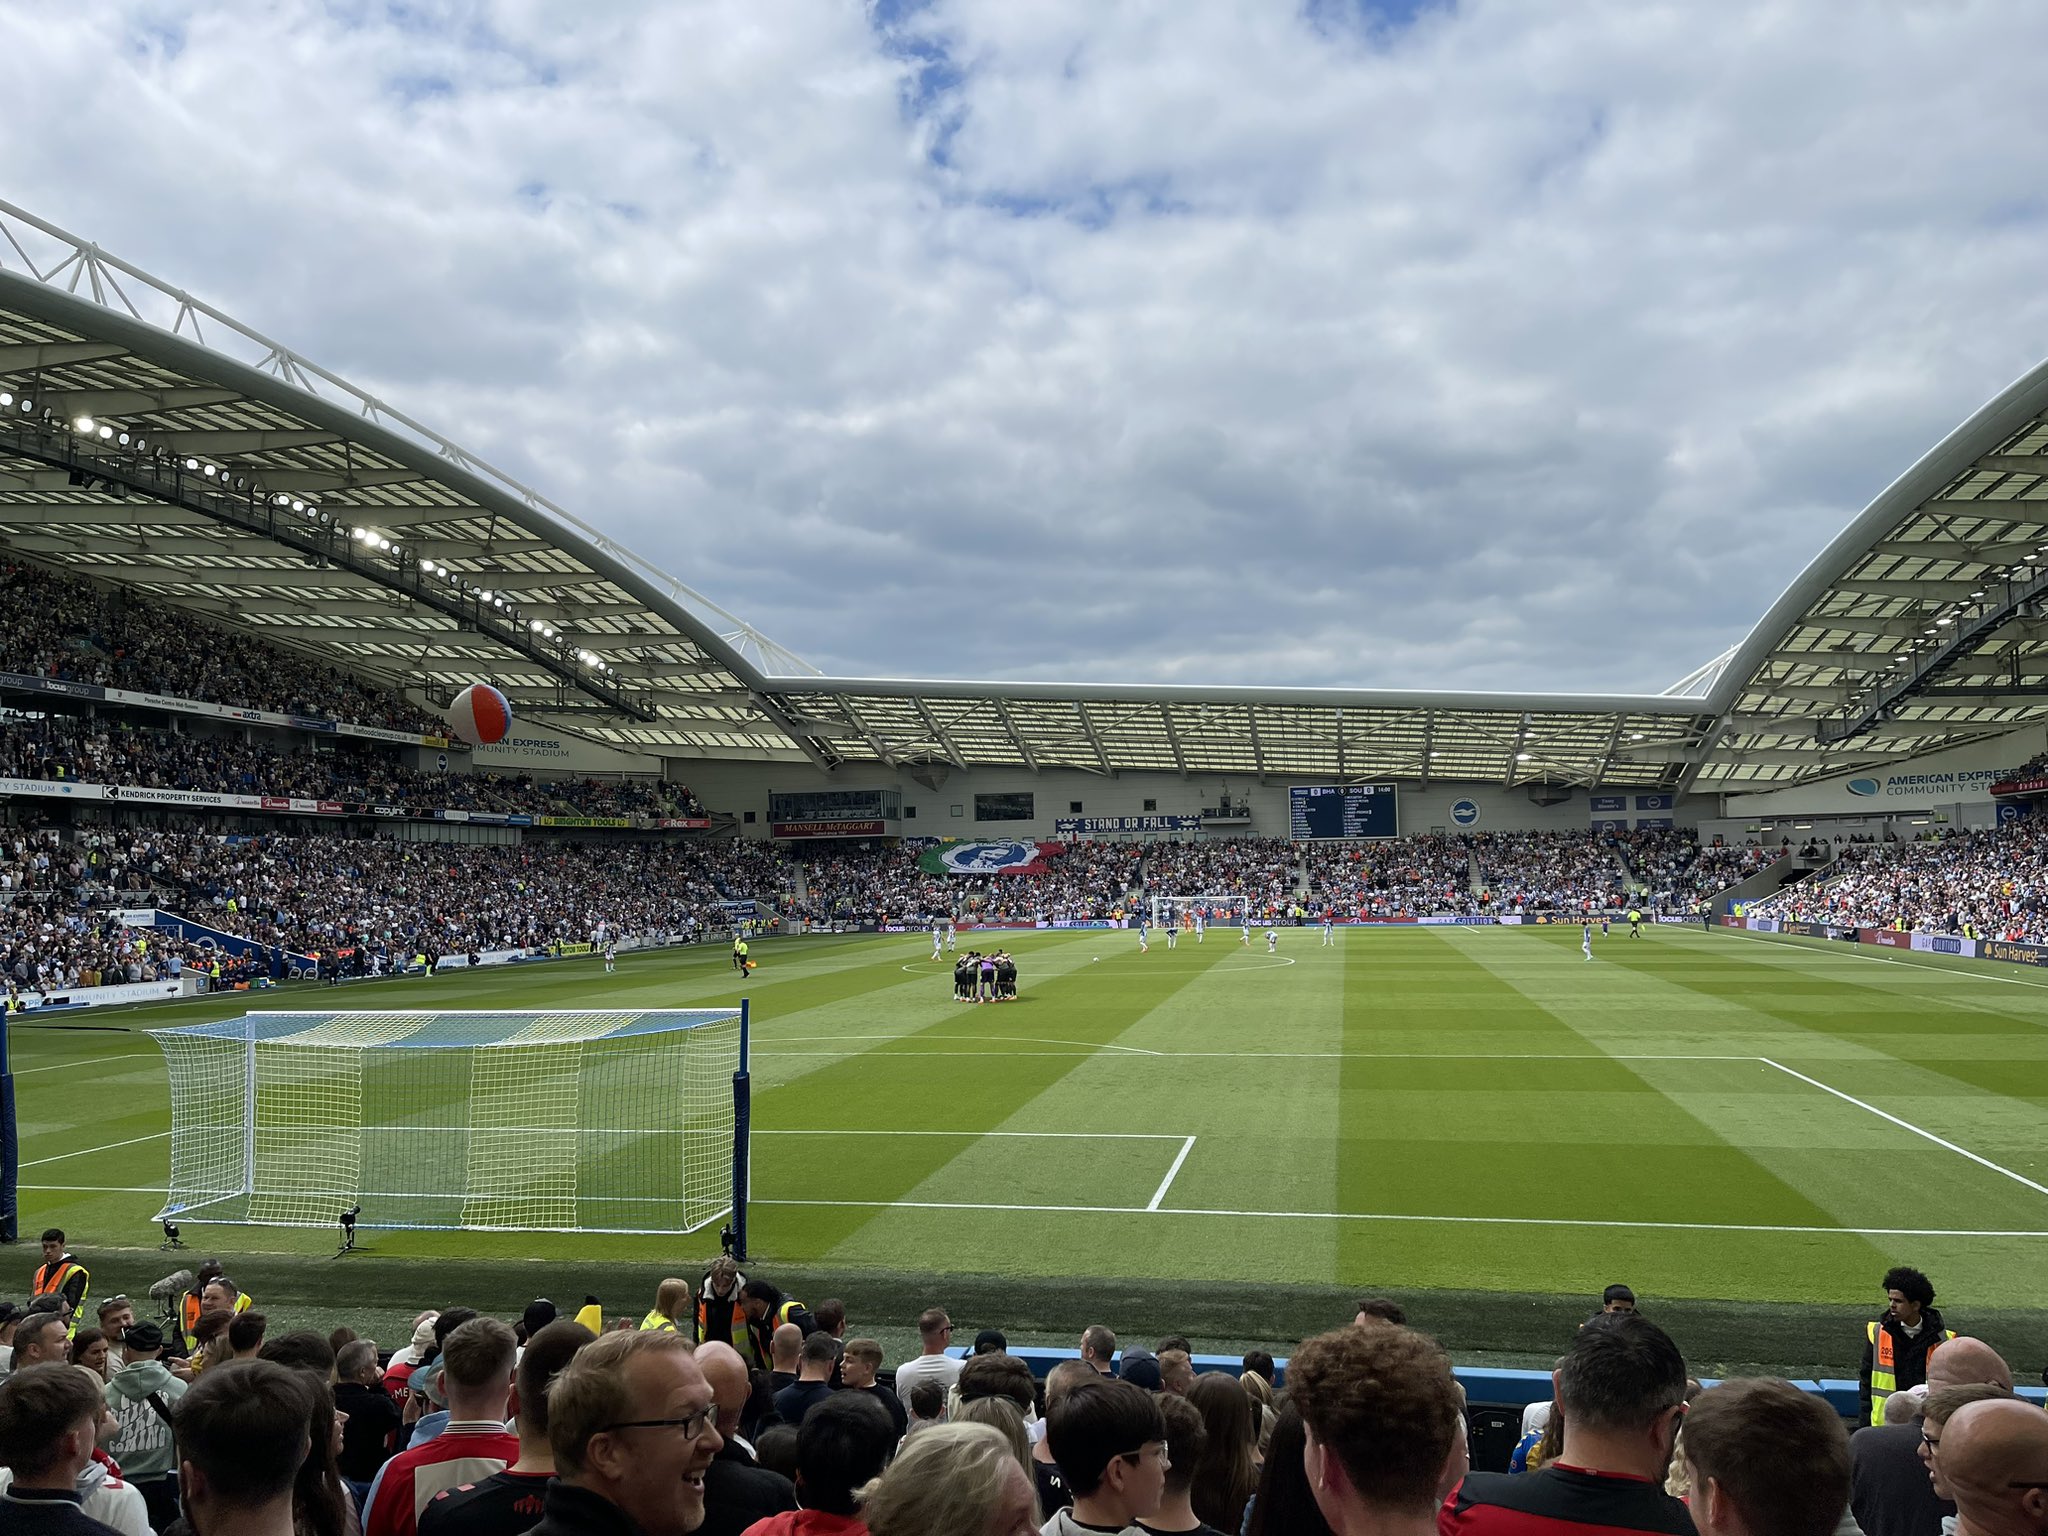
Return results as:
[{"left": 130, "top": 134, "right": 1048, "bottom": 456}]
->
[{"left": 1436, "top": 1313, "right": 1694, "bottom": 1536}]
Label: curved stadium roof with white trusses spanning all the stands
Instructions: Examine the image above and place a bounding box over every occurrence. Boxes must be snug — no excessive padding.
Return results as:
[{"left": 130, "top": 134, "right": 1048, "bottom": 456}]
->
[{"left": 0, "top": 203, "right": 2048, "bottom": 791}]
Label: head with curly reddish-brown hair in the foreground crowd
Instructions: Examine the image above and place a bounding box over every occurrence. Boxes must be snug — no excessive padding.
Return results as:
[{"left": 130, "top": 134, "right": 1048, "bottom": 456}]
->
[{"left": 1268, "top": 1323, "right": 1464, "bottom": 1530}]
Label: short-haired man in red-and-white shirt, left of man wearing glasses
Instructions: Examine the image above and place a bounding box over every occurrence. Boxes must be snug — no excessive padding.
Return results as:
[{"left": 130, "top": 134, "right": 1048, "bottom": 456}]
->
[{"left": 362, "top": 1317, "right": 528, "bottom": 1536}]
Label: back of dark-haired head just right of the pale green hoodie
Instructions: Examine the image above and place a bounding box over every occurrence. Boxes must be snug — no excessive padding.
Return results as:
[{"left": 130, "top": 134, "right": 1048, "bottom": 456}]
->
[{"left": 172, "top": 1360, "right": 317, "bottom": 1532}]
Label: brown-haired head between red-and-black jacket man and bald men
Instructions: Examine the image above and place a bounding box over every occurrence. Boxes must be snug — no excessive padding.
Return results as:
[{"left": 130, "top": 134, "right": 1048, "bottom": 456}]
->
[{"left": 1686, "top": 1378, "right": 1849, "bottom": 1536}]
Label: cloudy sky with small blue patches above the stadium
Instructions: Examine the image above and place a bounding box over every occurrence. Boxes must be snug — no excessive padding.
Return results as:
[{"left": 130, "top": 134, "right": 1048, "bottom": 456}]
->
[{"left": 0, "top": 0, "right": 2048, "bottom": 690}]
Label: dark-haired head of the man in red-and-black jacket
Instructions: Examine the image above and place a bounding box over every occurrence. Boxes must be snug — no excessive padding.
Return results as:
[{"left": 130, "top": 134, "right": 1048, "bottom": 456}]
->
[{"left": 1556, "top": 1313, "right": 1686, "bottom": 1479}]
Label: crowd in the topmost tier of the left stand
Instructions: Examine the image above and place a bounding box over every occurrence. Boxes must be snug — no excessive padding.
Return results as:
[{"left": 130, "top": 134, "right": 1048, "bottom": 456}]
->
[{"left": 0, "top": 565, "right": 449, "bottom": 735}]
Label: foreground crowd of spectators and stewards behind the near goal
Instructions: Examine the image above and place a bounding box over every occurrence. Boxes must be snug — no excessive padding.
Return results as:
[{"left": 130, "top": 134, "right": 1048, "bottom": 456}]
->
[{"left": 0, "top": 1253, "right": 2023, "bottom": 1536}]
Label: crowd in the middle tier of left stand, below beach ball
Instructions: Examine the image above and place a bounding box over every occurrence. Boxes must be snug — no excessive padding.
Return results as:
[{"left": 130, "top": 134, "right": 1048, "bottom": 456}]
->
[{"left": 0, "top": 715, "right": 702, "bottom": 819}]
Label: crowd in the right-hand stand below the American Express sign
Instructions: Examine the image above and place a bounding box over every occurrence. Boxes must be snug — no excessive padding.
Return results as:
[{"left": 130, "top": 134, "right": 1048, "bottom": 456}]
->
[{"left": 1753, "top": 821, "right": 2048, "bottom": 944}]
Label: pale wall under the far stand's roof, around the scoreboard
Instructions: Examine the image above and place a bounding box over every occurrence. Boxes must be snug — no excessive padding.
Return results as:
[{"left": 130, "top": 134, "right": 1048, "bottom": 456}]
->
[{"left": 686, "top": 758, "right": 1718, "bottom": 838}]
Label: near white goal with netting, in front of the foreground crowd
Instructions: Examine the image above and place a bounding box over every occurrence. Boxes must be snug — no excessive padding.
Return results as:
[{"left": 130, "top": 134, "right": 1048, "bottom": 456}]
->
[{"left": 152, "top": 1004, "right": 750, "bottom": 1253}]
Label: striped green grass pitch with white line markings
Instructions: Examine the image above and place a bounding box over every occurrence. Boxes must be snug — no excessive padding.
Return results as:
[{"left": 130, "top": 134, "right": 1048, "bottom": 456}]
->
[{"left": 16, "top": 928, "right": 2048, "bottom": 1372}]
